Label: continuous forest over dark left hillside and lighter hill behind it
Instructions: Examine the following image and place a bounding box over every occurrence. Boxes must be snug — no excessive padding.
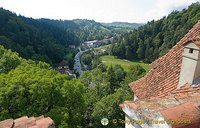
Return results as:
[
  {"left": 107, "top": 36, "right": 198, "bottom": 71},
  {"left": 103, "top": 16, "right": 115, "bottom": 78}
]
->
[{"left": 0, "top": 8, "right": 141, "bottom": 65}]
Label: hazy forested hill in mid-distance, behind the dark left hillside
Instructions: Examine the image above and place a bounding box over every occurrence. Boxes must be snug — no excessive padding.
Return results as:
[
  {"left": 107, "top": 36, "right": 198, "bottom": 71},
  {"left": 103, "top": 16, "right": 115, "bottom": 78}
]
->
[{"left": 39, "top": 19, "right": 114, "bottom": 42}]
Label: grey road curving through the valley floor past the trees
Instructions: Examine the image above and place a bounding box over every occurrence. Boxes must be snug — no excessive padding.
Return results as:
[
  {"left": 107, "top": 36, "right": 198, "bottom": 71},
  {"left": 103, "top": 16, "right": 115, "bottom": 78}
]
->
[{"left": 74, "top": 50, "right": 88, "bottom": 75}]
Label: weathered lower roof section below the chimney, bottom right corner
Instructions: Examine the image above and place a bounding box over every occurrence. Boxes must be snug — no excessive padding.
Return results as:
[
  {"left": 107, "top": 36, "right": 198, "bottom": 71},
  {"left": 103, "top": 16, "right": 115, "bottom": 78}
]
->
[{"left": 120, "top": 84, "right": 200, "bottom": 128}]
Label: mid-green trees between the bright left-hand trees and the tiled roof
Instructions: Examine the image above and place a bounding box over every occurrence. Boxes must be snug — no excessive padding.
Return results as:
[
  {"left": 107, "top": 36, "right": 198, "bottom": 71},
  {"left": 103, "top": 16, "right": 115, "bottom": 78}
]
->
[{"left": 79, "top": 59, "right": 146, "bottom": 128}]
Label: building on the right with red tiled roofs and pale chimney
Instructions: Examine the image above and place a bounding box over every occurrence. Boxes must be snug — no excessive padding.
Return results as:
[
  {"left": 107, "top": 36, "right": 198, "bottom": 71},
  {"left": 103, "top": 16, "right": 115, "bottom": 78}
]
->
[{"left": 120, "top": 21, "right": 200, "bottom": 128}]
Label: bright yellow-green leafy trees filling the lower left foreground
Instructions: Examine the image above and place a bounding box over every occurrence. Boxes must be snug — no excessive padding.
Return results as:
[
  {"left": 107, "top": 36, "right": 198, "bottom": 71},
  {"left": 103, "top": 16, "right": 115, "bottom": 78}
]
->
[{"left": 0, "top": 47, "right": 85, "bottom": 128}]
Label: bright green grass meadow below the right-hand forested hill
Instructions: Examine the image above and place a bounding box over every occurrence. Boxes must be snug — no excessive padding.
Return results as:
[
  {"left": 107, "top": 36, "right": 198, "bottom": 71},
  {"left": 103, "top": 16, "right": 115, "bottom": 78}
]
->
[{"left": 100, "top": 56, "right": 151, "bottom": 72}]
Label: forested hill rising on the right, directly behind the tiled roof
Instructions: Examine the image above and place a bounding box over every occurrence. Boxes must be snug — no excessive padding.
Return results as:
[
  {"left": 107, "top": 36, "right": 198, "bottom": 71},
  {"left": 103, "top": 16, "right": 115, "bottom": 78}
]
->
[{"left": 111, "top": 3, "right": 200, "bottom": 62}]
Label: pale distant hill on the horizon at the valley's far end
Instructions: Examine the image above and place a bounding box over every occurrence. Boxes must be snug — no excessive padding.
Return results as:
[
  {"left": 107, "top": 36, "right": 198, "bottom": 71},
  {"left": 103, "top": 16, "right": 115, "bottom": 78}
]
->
[{"left": 101, "top": 22, "right": 144, "bottom": 29}]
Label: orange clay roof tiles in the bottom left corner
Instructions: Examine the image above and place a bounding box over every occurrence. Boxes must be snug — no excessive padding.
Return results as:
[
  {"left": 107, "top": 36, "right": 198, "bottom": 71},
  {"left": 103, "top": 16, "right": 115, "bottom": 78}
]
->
[{"left": 0, "top": 115, "right": 55, "bottom": 128}]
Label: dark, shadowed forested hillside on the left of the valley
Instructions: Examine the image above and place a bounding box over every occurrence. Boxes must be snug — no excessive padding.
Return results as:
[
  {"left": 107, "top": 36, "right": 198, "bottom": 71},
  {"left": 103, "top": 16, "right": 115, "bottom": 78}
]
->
[{"left": 0, "top": 8, "right": 80, "bottom": 64}]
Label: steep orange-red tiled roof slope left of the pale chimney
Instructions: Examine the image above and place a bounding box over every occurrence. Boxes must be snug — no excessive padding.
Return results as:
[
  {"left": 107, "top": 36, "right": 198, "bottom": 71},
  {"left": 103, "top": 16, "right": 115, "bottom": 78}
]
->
[{"left": 129, "top": 20, "right": 200, "bottom": 99}]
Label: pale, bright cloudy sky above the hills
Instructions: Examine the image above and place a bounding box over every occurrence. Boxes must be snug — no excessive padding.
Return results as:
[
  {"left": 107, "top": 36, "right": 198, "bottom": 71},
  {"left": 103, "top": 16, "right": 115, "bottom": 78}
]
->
[{"left": 0, "top": 0, "right": 200, "bottom": 23}]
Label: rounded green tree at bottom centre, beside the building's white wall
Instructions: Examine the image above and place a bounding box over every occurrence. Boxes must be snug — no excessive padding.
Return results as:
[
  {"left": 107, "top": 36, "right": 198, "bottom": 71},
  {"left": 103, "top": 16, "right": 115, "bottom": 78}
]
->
[{"left": 92, "top": 89, "right": 133, "bottom": 128}]
